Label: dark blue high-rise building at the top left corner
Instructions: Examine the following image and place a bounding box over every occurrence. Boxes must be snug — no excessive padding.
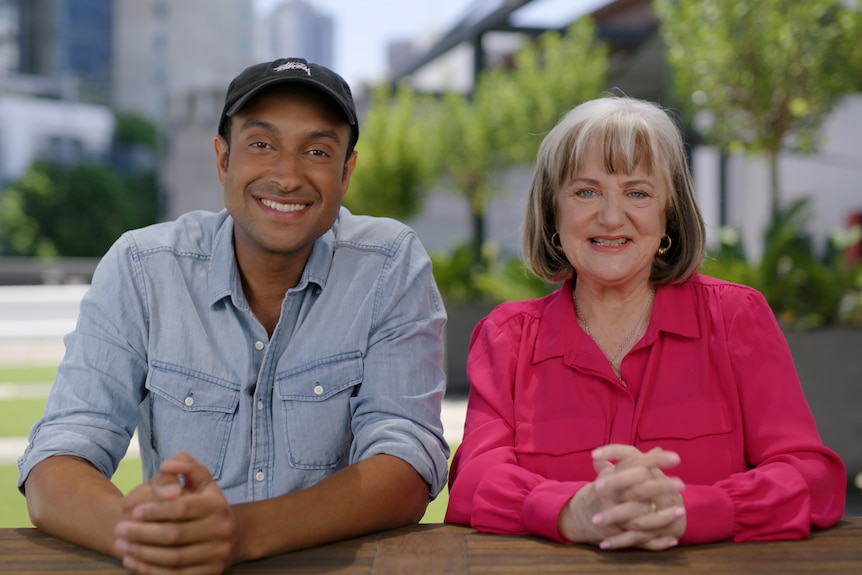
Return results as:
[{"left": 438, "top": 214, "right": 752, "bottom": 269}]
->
[{"left": 17, "top": 0, "right": 114, "bottom": 104}]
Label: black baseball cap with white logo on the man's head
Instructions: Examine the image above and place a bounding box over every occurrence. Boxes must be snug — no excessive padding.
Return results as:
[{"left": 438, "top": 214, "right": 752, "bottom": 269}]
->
[{"left": 223, "top": 58, "right": 359, "bottom": 148}]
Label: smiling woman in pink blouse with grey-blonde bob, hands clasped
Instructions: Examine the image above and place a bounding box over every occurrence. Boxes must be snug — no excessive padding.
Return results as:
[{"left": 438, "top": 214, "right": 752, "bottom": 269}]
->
[{"left": 446, "top": 97, "right": 847, "bottom": 550}]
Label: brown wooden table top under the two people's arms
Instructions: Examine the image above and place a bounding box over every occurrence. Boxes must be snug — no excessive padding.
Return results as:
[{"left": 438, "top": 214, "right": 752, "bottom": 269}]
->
[{"left": 0, "top": 517, "right": 862, "bottom": 575}]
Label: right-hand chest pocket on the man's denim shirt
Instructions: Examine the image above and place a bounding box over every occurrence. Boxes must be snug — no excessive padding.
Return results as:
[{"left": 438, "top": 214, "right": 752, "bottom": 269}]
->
[{"left": 275, "top": 352, "right": 363, "bottom": 470}]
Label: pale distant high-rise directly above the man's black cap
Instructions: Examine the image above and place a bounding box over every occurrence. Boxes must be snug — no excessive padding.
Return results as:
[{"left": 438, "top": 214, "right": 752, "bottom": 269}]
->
[{"left": 258, "top": 0, "right": 333, "bottom": 68}]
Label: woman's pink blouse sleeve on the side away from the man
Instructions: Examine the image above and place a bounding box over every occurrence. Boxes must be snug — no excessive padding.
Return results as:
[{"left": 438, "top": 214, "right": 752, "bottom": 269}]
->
[{"left": 681, "top": 291, "right": 847, "bottom": 544}]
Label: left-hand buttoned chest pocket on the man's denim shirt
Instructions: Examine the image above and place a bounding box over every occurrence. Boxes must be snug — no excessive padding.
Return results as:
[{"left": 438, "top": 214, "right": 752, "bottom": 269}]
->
[{"left": 146, "top": 362, "right": 240, "bottom": 480}]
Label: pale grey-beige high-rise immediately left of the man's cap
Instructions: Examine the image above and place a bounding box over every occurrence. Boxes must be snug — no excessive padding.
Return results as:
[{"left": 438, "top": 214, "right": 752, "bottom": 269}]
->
[{"left": 113, "top": 0, "right": 256, "bottom": 219}]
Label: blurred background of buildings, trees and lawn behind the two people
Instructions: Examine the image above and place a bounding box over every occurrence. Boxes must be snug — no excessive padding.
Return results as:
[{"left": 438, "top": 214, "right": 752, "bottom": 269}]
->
[{"left": 0, "top": 0, "right": 862, "bottom": 515}]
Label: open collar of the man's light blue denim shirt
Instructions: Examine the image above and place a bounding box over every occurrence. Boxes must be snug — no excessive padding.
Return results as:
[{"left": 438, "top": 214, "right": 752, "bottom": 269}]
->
[{"left": 208, "top": 208, "right": 344, "bottom": 311}]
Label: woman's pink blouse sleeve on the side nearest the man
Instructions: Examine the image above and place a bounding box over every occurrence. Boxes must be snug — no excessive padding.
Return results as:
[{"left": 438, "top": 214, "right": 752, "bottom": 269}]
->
[{"left": 446, "top": 319, "right": 586, "bottom": 542}]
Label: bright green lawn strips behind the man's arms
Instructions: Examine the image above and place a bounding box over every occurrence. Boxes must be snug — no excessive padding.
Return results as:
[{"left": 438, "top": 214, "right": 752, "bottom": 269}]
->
[{"left": 0, "top": 367, "right": 457, "bottom": 527}]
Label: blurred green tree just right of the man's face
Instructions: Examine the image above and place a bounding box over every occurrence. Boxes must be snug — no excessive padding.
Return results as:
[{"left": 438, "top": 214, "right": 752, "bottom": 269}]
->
[{"left": 344, "top": 84, "right": 434, "bottom": 219}]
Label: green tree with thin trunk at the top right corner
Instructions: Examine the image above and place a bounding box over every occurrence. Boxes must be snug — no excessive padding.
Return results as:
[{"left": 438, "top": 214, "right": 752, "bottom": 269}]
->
[{"left": 654, "top": 0, "right": 862, "bottom": 219}]
